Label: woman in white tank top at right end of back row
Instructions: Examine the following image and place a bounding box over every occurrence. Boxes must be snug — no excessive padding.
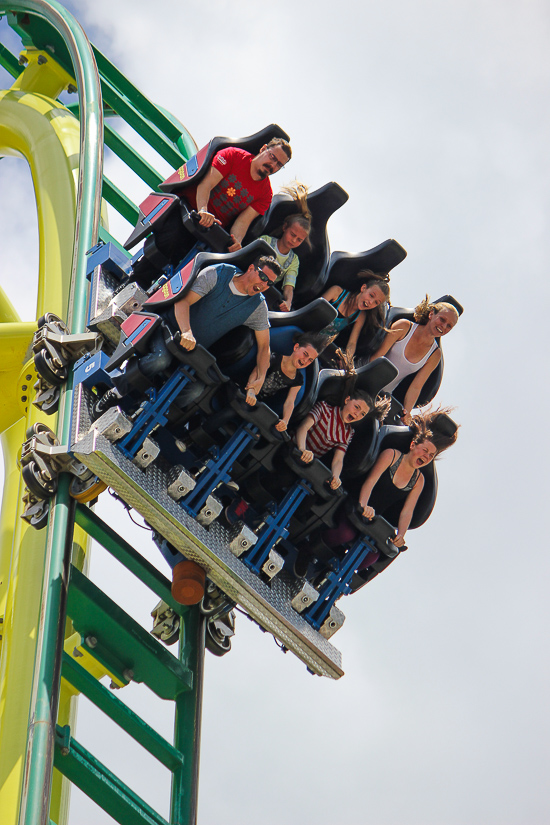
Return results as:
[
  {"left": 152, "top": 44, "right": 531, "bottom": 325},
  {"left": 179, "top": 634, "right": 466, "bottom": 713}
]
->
[{"left": 370, "top": 296, "right": 458, "bottom": 425}]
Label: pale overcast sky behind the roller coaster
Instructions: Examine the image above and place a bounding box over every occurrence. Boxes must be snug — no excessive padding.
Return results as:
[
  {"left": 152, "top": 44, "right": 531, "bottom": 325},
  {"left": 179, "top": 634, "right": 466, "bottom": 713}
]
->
[{"left": 0, "top": 0, "right": 550, "bottom": 825}]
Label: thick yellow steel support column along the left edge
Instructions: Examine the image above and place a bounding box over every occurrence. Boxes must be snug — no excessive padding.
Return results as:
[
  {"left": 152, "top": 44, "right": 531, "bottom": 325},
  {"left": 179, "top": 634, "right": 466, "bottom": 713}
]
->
[{"left": 0, "top": 58, "right": 91, "bottom": 825}]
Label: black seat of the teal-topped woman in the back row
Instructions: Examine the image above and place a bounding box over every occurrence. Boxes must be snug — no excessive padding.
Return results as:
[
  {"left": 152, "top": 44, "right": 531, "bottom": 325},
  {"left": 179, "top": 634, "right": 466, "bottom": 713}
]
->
[{"left": 323, "top": 239, "right": 407, "bottom": 357}]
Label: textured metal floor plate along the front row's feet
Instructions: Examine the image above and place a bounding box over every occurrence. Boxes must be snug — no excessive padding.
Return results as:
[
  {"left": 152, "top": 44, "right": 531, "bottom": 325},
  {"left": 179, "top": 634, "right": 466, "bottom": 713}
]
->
[{"left": 71, "top": 385, "right": 344, "bottom": 679}]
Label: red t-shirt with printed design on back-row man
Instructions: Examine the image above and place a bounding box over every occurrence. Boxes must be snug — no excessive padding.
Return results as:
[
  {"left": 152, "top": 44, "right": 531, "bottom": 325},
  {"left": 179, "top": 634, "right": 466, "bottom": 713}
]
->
[{"left": 182, "top": 146, "right": 273, "bottom": 226}]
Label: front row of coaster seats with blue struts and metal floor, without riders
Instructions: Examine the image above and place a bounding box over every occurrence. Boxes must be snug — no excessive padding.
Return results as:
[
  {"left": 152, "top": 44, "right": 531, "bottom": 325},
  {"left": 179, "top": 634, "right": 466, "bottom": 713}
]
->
[{"left": 71, "top": 229, "right": 462, "bottom": 675}]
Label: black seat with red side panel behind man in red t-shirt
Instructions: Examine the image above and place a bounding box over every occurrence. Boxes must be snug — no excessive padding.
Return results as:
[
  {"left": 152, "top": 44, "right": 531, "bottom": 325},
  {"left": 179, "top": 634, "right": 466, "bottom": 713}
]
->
[{"left": 124, "top": 123, "right": 289, "bottom": 251}]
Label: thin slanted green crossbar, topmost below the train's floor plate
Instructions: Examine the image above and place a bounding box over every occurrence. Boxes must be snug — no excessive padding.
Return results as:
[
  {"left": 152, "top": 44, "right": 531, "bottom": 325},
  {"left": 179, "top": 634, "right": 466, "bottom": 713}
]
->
[{"left": 75, "top": 504, "right": 185, "bottom": 614}]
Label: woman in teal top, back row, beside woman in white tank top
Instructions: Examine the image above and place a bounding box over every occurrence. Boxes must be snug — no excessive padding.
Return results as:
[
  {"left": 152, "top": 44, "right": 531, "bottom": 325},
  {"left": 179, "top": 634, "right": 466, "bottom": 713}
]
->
[{"left": 321, "top": 269, "right": 390, "bottom": 360}]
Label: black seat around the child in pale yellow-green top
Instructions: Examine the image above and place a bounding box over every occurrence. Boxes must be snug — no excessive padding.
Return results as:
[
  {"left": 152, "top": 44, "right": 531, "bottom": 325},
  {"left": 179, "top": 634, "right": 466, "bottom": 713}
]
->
[{"left": 245, "top": 182, "right": 349, "bottom": 306}]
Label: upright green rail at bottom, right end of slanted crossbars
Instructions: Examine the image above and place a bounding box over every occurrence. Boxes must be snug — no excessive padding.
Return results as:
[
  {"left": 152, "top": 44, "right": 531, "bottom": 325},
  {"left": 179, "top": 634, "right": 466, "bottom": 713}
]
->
[{"left": 170, "top": 607, "right": 205, "bottom": 825}]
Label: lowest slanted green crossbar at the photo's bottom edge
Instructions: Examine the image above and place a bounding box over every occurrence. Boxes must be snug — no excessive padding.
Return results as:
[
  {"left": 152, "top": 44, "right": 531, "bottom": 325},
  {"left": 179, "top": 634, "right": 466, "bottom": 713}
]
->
[{"left": 54, "top": 725, "right": 168, "bottom": 825}]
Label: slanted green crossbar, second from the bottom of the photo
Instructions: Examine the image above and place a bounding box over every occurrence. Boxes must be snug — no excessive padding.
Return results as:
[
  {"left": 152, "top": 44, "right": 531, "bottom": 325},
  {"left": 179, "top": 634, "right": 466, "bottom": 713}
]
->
[{"left": 62, "top": 653, "right": 183, "bottom": 771}]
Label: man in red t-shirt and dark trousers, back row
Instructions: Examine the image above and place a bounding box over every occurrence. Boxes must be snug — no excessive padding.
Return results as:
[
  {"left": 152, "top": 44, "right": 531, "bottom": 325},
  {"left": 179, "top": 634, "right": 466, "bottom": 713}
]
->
[{"left": 133, "top": 138, "right": 292, "bottom": 289}]
